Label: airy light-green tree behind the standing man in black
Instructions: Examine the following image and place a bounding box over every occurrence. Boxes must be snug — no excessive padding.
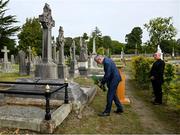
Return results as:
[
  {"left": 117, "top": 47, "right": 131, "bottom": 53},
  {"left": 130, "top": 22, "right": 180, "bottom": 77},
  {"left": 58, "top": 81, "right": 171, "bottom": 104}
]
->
[{"left": 144, "top": 17, "right": 177, "bottom": 51}]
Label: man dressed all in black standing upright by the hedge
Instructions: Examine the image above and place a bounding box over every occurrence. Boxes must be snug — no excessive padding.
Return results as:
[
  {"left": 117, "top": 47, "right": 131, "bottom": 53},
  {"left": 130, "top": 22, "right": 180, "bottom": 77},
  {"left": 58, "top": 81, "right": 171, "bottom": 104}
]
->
[{"left": 150, "top": 53, "right": 165, "bottom": 105}]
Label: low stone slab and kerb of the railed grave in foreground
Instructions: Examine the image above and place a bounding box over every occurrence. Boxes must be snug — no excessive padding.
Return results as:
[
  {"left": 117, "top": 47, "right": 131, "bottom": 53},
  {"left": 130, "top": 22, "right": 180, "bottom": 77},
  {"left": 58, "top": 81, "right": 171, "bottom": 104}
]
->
[{"left": 0, "top": 104, "right": 72, "bottom": 133}]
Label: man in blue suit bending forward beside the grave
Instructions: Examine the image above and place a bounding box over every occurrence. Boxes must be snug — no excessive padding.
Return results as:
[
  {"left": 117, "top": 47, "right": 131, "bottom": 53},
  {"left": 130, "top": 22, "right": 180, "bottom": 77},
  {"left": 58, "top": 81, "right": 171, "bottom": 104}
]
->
[{"left": 94, "top": 55, "right": 123, "bottom": 116}]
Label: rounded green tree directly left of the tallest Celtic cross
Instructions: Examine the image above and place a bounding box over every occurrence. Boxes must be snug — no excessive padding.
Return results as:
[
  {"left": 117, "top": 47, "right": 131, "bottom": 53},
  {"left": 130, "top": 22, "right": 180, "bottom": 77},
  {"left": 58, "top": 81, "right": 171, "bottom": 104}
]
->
[{"left": 18, "top": 18, "right": 42, "bottom": 55}]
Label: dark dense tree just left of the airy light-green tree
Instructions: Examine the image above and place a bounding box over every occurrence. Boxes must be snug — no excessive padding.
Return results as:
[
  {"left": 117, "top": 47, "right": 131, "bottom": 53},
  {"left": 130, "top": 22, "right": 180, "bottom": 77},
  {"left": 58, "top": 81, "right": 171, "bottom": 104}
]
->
[{"left": 125, "top": 27, "right": 143, "bottom": 53}]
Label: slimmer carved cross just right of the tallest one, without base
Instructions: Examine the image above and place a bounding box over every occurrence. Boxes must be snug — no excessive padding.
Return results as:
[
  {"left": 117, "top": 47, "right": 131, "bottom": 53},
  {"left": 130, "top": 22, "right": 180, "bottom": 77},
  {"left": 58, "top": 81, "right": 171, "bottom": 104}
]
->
[{"left": 57, "top": 26, "right": 65, "bottom": 65}]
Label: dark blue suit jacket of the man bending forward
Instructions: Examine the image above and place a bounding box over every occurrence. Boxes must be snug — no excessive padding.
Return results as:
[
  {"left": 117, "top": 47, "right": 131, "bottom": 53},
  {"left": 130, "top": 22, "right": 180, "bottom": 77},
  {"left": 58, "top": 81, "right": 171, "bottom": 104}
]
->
[{"left": 101, "top": 57, "right": 121, "bottom": 87}]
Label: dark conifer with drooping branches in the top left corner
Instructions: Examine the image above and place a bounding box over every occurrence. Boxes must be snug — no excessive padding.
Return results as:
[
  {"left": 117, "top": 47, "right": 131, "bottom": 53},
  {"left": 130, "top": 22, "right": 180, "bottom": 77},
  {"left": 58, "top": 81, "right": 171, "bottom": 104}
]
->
[{"left": 0, "top": 0, "right": 20, "bottom": 57}]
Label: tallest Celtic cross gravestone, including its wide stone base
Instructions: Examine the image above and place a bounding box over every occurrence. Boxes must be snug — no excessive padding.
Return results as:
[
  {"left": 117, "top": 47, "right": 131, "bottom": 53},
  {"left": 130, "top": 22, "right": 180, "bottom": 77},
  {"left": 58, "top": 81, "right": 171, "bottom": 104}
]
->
[{"left": 35, "top": 3, "right": 58, "bottom": 79}]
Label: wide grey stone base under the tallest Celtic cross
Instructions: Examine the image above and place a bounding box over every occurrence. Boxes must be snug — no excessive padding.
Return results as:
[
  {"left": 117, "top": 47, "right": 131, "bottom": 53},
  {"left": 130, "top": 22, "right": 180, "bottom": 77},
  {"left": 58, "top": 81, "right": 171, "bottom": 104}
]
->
[{"left": 35, "top": 62, "right": 58, "bottom": 79}]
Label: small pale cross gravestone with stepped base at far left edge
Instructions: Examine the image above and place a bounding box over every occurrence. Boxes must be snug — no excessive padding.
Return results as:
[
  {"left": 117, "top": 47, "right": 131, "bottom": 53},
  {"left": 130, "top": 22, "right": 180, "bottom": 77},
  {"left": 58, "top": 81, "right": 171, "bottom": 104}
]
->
[{"left": 1, "top": 46, "right": 12, "bottom": 72}]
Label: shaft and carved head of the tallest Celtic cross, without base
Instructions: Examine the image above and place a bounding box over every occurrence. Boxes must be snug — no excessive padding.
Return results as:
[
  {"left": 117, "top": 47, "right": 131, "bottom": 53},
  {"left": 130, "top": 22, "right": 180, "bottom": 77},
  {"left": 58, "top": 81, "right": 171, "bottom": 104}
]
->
[{"left": 39, "top": 3, "right": 55, "bottom": 62}]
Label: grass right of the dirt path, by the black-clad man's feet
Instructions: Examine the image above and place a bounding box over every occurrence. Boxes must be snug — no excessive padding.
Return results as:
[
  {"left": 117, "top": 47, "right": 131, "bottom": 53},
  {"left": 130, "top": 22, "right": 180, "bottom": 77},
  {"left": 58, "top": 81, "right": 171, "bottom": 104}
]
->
[{"left": 131, "top": 80, "right": 180, "bottom": 133}]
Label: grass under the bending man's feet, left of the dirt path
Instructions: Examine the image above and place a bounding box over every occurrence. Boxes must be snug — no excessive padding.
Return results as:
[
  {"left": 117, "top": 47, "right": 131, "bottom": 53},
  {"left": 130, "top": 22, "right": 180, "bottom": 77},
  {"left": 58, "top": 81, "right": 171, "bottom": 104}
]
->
[{"left": 55, "top": 89, "right": 145, "bottom": 134}]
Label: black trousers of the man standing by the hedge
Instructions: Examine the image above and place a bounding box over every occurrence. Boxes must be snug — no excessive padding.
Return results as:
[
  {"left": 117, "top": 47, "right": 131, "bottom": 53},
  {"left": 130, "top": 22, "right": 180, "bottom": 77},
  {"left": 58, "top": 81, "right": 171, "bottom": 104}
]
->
[{"left": 151, "top": 80, "right": 162, "bottom": 103}]
